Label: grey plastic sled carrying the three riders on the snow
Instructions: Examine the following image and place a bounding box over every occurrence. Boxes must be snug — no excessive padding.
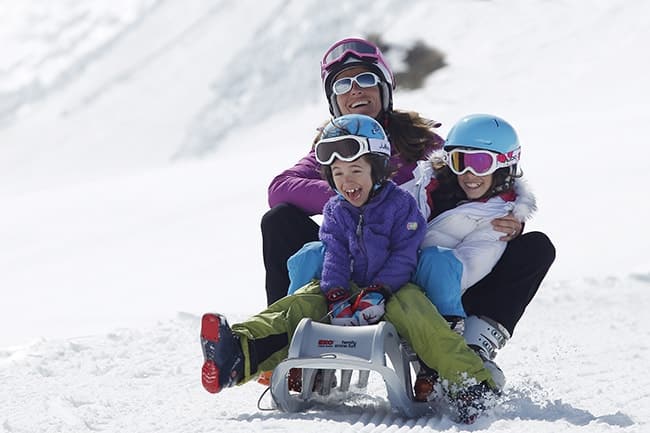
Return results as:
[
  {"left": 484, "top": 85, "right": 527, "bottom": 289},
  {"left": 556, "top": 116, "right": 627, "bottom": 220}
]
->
[{"left": 271, "top": 319, "right": 431, "bottom": 417}]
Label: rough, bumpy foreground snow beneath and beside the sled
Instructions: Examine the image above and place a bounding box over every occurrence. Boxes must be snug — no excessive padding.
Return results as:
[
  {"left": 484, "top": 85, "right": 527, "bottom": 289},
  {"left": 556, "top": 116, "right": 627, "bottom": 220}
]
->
[{"left": 0, "top": 278, "right": 650, "bottom": 433}]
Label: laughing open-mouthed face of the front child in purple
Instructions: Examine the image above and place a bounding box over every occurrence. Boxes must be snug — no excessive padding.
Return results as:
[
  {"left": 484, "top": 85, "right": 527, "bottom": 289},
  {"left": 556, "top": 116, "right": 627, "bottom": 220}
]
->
[{"left": 332, "top": 157, "right": 373, "bottom": 207}]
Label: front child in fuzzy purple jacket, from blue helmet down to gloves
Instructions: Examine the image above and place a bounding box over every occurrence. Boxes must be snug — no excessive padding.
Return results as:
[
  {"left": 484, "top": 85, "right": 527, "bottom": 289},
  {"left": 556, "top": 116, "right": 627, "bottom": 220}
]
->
[{"left": 315, "top": 114, "right": 426, "bottom": 325}]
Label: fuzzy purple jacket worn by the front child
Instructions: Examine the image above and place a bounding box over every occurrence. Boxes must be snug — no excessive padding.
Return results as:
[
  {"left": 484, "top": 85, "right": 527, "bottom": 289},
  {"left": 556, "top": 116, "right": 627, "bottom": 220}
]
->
[{"left": 320, "top": 181, "right": 426, "bottom": 292}]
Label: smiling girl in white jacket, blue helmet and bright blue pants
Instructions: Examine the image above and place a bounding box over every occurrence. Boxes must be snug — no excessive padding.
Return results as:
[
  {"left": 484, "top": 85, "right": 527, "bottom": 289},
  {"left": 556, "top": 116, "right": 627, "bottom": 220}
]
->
[{"left": 403, "top": 115, "right": 536, "bottom": 317}]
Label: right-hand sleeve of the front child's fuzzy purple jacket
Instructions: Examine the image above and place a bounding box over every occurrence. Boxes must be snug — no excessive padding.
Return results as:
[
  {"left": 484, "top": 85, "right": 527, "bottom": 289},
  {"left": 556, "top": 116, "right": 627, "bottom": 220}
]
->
[{"left": 375, "top": 190, "right": 426, "bottom": 292}]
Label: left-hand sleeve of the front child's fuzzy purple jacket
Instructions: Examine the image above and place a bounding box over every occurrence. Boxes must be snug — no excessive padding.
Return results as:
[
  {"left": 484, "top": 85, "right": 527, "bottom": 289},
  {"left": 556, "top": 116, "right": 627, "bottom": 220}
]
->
[{"left": 319, "top": 199, "right": 352, "bottom": 293}]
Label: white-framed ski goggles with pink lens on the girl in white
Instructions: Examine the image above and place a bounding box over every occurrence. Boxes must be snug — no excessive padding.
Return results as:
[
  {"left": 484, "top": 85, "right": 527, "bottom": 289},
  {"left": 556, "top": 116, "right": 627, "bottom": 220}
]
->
[{"left": 444, "top": 149, "right": 521, "bottom": 176}]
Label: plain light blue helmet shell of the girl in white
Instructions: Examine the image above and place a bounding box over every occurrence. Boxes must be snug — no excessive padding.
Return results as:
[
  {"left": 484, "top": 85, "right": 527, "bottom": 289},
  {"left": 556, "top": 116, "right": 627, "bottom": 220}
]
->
[{"left": 444, "top": 114, "right": 520, "bottom": 156}]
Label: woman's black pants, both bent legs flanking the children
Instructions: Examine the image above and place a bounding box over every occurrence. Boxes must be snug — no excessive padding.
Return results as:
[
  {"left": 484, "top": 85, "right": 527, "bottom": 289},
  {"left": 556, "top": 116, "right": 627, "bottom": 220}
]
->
[{"left": 262, "top": 204, "right": 555, "bottom": 334}]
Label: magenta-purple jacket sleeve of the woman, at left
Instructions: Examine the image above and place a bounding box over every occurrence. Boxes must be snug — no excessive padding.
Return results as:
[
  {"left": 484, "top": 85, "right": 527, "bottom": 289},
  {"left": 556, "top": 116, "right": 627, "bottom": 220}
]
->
[{"left": 268, "top": 150, "right": 334, "bottom": 215}]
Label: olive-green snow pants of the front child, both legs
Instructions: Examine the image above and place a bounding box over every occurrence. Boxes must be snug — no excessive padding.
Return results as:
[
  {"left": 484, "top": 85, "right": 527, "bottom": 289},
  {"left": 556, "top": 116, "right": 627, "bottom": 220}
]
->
[{"left": 232, "top": 281, "right": 494, "bottom": 386}]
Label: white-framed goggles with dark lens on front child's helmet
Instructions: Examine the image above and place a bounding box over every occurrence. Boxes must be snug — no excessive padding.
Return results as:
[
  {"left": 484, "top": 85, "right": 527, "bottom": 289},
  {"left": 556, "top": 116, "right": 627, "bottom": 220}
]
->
[{"left": 314, "top": 135, "right": 390, "bottom": 165}]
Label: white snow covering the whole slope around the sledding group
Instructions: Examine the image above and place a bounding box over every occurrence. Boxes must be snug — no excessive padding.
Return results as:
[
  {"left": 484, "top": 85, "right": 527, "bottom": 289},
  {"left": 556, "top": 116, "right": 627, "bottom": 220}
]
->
[{"left": 0, "top": 0, "right": 650, "bottom": 433}]
